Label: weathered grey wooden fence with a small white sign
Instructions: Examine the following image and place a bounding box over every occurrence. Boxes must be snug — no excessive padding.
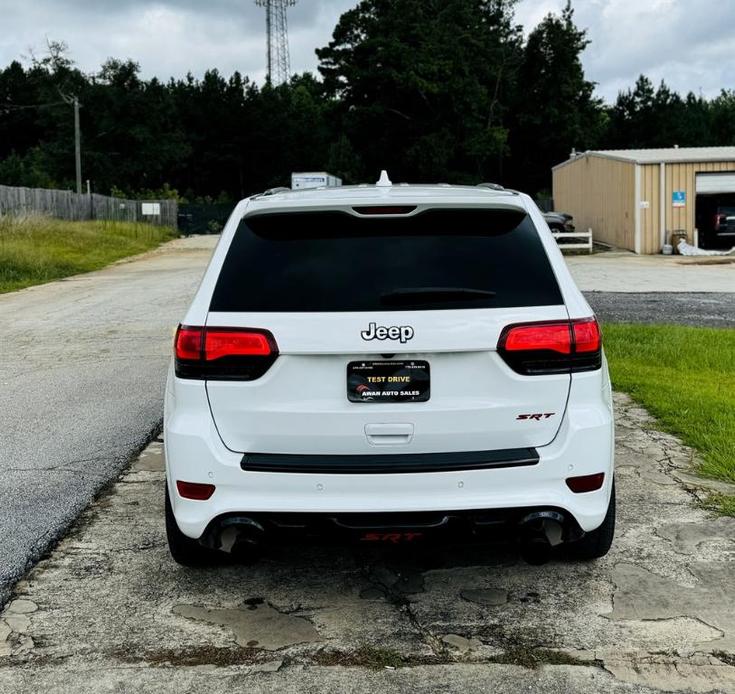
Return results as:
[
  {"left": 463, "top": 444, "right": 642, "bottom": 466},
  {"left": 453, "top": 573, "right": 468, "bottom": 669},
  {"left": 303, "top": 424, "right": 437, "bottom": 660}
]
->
[{"left": 0, "top": 185, "right": 178, "bottom": 229}]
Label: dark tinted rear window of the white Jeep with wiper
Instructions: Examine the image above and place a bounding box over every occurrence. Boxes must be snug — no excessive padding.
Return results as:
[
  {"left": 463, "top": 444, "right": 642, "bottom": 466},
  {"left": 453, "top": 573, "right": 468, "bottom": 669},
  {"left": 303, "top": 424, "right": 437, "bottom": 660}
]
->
[{"left": 210, "top": 209, "right": 563, "bottom": 312}]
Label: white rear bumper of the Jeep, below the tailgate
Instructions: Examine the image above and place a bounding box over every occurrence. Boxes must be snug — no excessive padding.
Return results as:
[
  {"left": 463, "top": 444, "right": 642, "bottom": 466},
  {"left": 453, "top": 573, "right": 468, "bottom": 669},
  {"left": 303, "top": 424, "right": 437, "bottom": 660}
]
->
[{"left": 164, "top": 372, "right": 613, "bottom": 538}]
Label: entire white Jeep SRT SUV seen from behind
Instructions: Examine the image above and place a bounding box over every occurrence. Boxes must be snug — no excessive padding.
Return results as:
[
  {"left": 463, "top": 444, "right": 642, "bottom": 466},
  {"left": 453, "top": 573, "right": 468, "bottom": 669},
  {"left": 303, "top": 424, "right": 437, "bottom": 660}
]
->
[{"left": 164, "top": 177, "right": 615, "bottom": 565}]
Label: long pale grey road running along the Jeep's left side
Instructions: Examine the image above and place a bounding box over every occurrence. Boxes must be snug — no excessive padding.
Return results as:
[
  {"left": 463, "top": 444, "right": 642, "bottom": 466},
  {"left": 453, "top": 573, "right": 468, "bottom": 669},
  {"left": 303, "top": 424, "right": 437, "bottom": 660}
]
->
[{"left": 0, "top": 238, "right": 212, "bottom": 605}]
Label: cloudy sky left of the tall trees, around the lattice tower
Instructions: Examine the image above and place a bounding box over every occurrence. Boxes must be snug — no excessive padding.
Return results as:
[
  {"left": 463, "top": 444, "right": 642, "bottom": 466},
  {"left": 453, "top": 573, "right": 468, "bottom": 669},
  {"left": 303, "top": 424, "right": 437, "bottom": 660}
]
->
[{"left": 0, "top": 0, "right": 354, "bottom": 82}]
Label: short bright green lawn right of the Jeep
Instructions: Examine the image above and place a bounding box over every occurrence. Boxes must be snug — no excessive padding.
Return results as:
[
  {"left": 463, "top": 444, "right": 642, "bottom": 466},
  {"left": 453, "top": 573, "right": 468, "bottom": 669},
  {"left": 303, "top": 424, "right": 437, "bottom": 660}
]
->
[{"left": 603, "top": 324, "right": 735, "bottom": 512}]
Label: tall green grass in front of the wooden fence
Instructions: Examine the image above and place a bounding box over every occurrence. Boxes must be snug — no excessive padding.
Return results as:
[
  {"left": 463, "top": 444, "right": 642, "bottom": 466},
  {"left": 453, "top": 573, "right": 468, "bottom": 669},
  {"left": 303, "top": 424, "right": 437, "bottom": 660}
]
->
[{"left": 0, "top": 216, "right": 174, "bottom": 293}]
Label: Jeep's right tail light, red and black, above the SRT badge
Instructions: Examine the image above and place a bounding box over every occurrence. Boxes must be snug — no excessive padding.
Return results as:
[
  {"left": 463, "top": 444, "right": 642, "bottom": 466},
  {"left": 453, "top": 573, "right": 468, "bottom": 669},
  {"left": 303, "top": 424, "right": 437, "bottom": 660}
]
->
[{"left": 498, "top": 318, "right": 602, "bottom": 375}]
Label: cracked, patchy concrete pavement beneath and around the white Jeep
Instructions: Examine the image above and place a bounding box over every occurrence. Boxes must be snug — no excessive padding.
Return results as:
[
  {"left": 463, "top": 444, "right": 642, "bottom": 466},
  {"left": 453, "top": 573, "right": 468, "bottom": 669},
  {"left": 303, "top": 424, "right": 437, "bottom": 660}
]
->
[{"left": 0, "top": 394, "right": 735, "bottom": 694}]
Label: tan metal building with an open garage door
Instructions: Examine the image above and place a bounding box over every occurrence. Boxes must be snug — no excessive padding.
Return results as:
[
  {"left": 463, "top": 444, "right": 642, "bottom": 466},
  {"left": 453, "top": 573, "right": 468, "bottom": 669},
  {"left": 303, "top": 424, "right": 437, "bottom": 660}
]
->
[{"left": 552, "top": 147, "right": 735, "bottom": 253}]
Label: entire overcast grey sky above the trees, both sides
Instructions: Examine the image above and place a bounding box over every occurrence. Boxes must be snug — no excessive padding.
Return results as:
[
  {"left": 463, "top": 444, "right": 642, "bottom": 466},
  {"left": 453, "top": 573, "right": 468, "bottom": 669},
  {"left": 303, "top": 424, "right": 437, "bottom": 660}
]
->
[{"left": 0, "top": 0, "right": 735, "bottom": 101}]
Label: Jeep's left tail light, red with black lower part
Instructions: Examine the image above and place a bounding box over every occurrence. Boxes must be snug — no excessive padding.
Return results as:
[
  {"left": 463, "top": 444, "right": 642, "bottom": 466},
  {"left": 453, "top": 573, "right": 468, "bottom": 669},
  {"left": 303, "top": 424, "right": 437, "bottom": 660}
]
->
[{"left": 174, "top": 325, "right": 278, "bottom": 381}]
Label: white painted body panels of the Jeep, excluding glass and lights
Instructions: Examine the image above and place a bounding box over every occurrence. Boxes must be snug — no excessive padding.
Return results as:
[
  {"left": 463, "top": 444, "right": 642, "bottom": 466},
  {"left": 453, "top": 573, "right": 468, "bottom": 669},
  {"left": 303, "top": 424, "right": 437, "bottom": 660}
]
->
[{"left": 164, "top": 185, "right": 614, "bottom": 538}]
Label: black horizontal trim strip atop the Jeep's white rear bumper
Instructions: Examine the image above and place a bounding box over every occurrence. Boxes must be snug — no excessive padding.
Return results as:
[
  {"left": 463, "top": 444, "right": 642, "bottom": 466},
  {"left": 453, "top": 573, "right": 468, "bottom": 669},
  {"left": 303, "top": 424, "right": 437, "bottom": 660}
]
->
[{"left": 240, "top": 448, "right": 539, "bottom": 475}]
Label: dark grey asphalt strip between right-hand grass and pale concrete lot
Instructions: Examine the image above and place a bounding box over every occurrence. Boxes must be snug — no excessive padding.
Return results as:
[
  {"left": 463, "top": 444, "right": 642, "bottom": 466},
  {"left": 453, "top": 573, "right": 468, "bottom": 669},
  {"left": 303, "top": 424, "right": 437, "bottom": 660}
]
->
[{"left": 584, "top": 292, "right": 735, "bottom": 328}]
